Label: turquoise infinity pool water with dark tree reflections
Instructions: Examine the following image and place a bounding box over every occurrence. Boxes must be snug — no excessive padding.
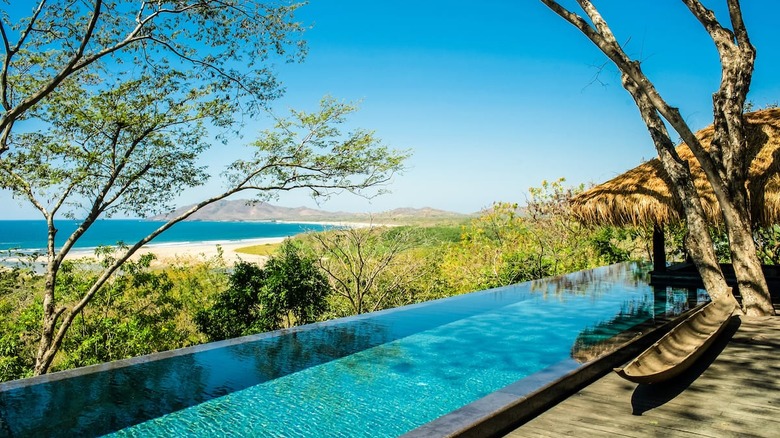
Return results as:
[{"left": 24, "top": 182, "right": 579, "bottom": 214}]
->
[{"left": 0, "top": 263, "right": 699, "bottom": 437}]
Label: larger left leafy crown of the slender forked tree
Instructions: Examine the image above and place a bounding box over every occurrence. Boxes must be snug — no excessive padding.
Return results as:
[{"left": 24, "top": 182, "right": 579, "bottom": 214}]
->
[{"left": 0, "top": 76, "right": 208, "bottom": 217}]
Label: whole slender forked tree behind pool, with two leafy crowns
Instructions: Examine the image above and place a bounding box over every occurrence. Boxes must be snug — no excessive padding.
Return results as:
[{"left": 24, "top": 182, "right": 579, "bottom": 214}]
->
[{"left": 0, "top": 78, "right": 407, "bottom": 374}]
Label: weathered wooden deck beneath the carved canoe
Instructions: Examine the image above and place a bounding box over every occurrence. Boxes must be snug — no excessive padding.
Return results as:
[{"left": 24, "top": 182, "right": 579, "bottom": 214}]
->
[{"left": 506, "top": 317, "right": 780, "bottom": 438}]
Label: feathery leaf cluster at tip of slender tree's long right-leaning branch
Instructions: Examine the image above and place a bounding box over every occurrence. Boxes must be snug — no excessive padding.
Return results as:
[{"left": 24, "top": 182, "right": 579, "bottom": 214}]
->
[{"left": 224, "top": 97, "right": 410, "bottom": 200}]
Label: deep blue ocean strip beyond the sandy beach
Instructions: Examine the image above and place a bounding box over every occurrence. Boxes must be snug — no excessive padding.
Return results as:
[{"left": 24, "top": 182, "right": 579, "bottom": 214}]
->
[{"left": 0, "top": 219, "right": 332, "bottom": 252}]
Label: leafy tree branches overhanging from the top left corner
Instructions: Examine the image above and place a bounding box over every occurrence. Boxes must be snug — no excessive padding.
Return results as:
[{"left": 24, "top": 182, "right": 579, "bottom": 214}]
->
[{"left": 0, "top": 0, "right": 305, "bottom": 157}]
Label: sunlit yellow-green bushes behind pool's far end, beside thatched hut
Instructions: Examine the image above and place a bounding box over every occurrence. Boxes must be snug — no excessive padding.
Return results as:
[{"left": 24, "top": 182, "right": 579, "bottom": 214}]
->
[{"left": 439, "top": 179, "right": 649, "bottom": 293}]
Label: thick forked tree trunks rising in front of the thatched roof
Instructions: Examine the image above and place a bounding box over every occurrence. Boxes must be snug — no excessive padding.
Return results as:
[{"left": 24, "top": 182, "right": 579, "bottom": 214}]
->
[{"left": 541, "top": 0, "right": 775, "bottom": 315}]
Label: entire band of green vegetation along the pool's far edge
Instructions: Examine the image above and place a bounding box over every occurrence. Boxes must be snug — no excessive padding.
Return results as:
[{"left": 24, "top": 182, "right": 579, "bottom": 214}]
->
[{"left": 0, "top": 181, "right": 643, "bottom": 380}]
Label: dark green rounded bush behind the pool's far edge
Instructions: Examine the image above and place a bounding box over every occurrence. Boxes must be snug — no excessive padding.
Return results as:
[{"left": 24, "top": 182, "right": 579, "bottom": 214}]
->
[{"left": 195, "top": 240, "right": 330, "bottom": 341}]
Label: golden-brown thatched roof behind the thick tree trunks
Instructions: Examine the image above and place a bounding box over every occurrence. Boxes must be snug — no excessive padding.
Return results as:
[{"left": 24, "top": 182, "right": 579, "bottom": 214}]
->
[{"left": 573, "top": 108, "right": 780, "bottom": 225}]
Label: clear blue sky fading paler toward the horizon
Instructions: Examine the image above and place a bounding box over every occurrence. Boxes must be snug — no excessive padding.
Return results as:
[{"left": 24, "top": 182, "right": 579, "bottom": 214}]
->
[{"left": 0, "top": 0, "right": 780, "bottom": 219}]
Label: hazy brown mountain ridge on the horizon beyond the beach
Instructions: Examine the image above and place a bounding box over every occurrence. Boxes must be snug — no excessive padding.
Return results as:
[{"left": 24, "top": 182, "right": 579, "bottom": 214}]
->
[{"left": 148, "top": 200, "right": 469, "bottom": 222}]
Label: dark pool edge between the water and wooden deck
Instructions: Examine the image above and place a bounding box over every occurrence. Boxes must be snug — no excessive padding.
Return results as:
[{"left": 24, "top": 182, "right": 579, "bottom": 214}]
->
[{"left": 402, "top": 304, "right": 704, "bottom": 438}]
